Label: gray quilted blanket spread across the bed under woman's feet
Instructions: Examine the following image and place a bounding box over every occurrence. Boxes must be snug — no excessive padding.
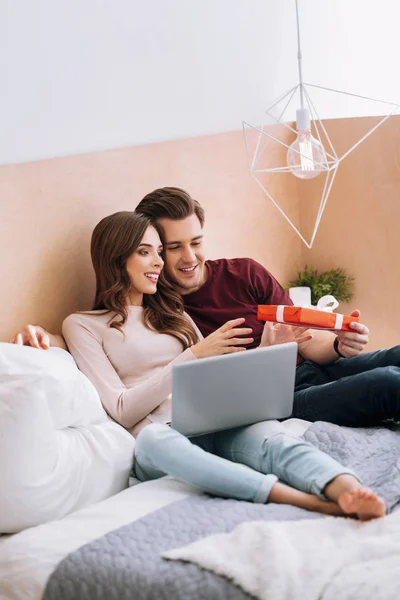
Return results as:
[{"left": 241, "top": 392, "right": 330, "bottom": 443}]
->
[{"left": 43, "top": 422, "right": 400, "bottom": 600}]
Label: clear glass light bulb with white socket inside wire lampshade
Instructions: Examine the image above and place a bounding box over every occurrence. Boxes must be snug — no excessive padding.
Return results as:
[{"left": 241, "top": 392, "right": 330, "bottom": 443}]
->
[{"left": 286, "top": 108, "right": 328, "bottom": 179}]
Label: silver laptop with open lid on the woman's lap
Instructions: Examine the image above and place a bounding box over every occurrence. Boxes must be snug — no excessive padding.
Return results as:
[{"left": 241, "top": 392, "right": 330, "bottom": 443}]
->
[{"left": 171, "top": 342, "right": 297, "bottom": 437}]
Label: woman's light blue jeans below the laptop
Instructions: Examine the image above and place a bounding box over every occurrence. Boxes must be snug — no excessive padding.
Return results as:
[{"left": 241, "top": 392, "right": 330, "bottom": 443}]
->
[{"left": 134, "top": 421, "right": 353, "bottom": 503}]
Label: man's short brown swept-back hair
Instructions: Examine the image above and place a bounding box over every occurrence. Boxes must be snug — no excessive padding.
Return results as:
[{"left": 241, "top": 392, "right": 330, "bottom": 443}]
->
[{"left": 135, "top": 187, "right": 204, "bottom": 227}]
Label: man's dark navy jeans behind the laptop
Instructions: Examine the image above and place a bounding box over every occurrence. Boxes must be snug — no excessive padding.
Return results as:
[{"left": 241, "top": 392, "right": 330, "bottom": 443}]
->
[{"left": 292, "top": 346, "right": 400, "bottom": 427}]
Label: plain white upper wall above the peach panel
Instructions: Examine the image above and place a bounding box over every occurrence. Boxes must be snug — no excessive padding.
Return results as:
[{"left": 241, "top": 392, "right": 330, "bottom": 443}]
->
[{"left": 0, "top": 0, "right": 400, "bottom": 164}]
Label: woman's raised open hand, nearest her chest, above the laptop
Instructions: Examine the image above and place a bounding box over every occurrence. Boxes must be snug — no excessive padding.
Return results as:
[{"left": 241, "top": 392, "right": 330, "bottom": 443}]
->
[{"left": 191, "top": 318, "right": 253, "bottom": 358}]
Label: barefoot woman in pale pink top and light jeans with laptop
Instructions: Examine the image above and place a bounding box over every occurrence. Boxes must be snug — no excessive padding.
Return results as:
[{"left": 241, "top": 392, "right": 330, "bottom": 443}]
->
[{"left": 15, "top": 212, "right": 385, "bottom": 520}]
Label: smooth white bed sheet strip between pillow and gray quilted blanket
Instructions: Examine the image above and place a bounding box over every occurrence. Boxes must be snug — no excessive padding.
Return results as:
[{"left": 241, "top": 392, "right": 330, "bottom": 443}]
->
[{"left": 0, "top": 419, "right": 310, "bottom": 600}]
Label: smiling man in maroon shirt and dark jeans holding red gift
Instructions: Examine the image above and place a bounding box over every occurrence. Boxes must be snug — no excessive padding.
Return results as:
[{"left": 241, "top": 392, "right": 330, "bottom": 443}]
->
[{"left": 136, "top": 187, "right": 400, "bottom": 427}]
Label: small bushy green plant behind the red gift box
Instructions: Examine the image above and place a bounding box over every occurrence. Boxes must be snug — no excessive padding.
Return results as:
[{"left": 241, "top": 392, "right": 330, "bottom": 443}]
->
[{"left": 286, "top": 265, "right": 354, "bottom": 305}]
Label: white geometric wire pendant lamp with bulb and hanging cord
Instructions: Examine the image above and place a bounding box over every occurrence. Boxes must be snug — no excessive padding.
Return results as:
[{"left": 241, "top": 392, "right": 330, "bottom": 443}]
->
[{"left": 243, "top": 0, "right": 399, "bottom": 248}]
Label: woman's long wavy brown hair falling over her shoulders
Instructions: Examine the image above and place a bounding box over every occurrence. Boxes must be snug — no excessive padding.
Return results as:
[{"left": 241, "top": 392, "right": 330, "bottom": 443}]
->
[{"left": 90, "top": 211, "right": 199, "bottom": 349}]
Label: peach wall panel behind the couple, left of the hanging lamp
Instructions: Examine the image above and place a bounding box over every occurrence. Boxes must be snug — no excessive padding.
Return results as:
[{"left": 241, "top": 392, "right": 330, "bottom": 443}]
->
[{"left": 0, "top": 132, "right": 301, "bottom": 341}]
